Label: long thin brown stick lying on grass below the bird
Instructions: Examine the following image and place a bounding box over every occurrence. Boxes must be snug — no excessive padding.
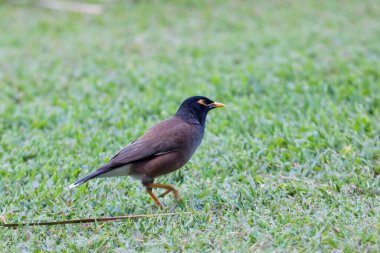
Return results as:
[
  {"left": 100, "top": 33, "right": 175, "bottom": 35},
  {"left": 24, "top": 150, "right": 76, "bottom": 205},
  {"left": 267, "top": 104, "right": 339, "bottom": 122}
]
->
[{"left": 0, "top": 212, "right": 192, "bottom": 228}]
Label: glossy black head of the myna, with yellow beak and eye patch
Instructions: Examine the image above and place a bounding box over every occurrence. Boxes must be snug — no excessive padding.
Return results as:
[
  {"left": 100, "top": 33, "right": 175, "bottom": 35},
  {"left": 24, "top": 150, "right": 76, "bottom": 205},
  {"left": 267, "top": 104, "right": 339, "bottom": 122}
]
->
[{"left": 175, "top": 96, "right": 224, "bottom": 126}]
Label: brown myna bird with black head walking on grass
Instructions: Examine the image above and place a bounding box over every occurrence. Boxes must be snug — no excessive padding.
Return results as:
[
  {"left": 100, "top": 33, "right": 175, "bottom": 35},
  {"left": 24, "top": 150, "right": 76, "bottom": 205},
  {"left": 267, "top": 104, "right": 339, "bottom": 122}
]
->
[{"left": 69, "top": 96, "right": 225, "bottom": 208}]
